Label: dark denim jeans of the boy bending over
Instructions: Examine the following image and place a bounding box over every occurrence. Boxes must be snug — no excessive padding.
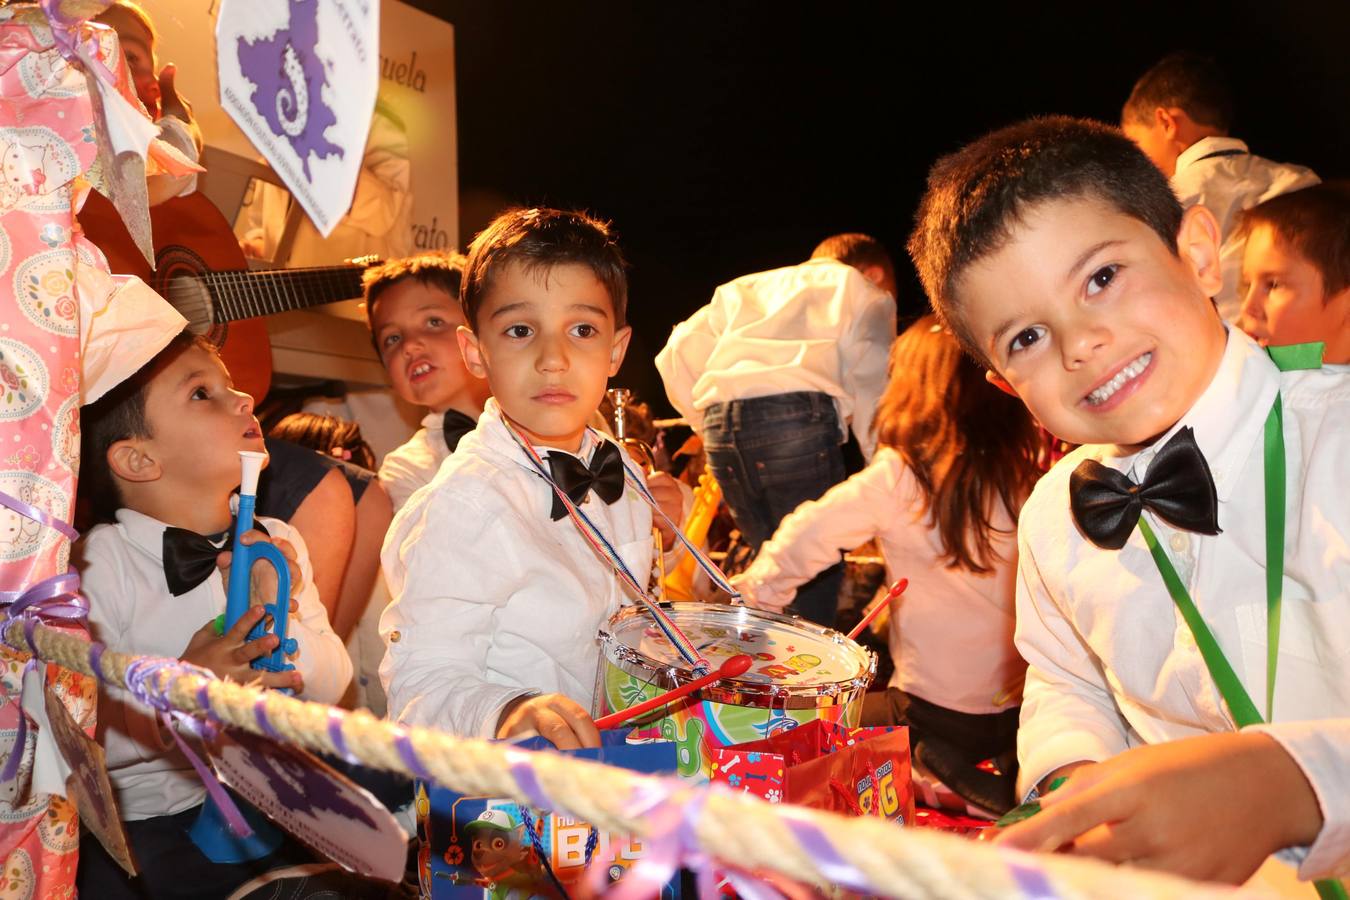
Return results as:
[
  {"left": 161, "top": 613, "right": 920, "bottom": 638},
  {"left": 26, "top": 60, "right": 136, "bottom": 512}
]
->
[{"left": 703, "top": 391, "right": 844, "bottom": 626}]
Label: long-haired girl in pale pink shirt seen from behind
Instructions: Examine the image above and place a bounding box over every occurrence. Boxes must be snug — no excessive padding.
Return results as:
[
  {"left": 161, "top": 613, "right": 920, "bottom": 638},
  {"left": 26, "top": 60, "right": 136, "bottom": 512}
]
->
[{"left": 733, "top": 316, "right": 1041, "bottom": 812}]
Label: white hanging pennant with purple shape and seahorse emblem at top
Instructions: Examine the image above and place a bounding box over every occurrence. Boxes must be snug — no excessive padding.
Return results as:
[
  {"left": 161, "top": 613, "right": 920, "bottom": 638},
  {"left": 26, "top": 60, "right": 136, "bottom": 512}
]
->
[{"left": 216, "top": 0, "right": 379, "bottom": 236}]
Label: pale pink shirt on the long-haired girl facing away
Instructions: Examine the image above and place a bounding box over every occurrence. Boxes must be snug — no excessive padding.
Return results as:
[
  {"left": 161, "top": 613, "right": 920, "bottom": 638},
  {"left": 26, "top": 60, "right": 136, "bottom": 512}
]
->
[{"left": 736, "top": 447, "right": 1026, "bottom": 714}]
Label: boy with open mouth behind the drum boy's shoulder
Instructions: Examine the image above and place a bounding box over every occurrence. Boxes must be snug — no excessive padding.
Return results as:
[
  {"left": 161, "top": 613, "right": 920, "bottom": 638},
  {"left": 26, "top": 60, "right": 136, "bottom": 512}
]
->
[{"left": 365, "top": 254, "right": 487, "bottom": 511}]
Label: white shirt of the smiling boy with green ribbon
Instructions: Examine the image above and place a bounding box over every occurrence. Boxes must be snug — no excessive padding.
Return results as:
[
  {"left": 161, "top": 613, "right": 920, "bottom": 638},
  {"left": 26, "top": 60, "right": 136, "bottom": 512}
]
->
[{"left": 1017, "top": 328, "right": 1350, "bottom": 878}]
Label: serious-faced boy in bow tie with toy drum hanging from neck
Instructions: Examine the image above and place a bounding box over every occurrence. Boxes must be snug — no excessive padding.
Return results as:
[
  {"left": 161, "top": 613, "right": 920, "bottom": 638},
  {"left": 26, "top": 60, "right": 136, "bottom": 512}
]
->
[{"left": 379, "top": 209, "right": 680, "bottom": 749}]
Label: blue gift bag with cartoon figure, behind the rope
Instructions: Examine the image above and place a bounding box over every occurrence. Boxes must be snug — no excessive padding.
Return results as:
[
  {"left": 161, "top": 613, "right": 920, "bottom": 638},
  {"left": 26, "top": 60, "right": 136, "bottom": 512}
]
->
[{"left": 416, "top": 731, "right": 678, "bottom": 900}]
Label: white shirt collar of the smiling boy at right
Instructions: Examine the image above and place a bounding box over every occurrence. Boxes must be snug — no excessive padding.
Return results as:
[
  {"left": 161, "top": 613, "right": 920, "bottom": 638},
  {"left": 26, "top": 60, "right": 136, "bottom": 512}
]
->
[{"left": 1111, "top": 328, "right": 1280, "bottom": 501}]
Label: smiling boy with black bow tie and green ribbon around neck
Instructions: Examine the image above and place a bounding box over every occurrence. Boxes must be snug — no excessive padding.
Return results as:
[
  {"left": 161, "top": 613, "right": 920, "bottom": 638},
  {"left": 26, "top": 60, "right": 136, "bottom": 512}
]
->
[{"left": 910, "top": 117, "right": 1350, "bottom": 896}]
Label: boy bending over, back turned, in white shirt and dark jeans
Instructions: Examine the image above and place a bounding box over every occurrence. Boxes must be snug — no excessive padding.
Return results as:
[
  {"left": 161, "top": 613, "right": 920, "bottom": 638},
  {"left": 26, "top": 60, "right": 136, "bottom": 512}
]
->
[{"left": 656, "top": 233, "right": 895, "bottom": 626}]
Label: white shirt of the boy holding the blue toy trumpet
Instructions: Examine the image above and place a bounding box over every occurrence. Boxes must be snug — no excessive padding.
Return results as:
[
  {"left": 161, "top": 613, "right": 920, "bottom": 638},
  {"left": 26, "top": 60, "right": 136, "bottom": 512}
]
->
[{"left": 74, "top": 509, "right": 351, "bottom": 820}]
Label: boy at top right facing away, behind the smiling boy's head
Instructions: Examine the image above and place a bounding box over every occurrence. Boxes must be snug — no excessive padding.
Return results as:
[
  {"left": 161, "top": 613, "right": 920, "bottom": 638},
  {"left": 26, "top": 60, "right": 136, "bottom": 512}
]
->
[{"left": 1121, "top": 53, "right": 1319, "bottom": 321}]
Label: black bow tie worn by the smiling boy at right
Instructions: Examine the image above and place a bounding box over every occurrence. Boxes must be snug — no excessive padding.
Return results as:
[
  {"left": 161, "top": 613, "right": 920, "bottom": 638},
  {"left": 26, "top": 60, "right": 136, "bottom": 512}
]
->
[{"left": 1069, "top": 428, "right": 1220, "bottom": 551}]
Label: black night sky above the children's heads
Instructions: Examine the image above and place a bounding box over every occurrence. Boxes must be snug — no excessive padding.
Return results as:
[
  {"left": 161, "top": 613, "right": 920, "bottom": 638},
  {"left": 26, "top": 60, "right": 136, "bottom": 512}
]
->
[{"left": 399, "top": 0, "right": 1350, "bottom": 412}]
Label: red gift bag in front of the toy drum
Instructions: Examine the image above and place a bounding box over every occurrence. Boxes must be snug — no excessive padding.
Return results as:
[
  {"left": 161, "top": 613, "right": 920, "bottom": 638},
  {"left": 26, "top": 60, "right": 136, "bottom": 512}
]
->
[{"left": 710, "top": 719, "right": 914, "bottom": 824}]
